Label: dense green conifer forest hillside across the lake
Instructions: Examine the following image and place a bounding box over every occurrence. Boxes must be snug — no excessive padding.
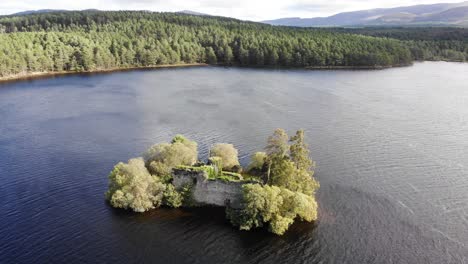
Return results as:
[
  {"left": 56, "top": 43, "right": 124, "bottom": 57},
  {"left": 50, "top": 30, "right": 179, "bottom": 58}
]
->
[{"left": 0, "top": 11, "right": 413, "bottom": 77}]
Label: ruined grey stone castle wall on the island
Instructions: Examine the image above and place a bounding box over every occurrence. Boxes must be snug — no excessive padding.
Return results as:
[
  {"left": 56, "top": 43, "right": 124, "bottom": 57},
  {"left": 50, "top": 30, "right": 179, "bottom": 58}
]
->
[{"left": 172, "top": 169, "right": 245, "bottom": 209}]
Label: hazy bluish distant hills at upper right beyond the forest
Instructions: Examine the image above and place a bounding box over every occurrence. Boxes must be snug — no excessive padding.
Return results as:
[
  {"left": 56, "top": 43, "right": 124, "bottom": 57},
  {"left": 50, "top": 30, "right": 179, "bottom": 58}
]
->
[{"left": 263, "top": 1, "right": 468, "bottom": 27}]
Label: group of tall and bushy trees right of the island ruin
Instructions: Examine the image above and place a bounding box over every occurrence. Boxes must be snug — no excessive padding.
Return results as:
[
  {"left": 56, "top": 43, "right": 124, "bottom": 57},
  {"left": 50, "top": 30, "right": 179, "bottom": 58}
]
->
[{"left": 227, "top": 129, "right": 319, "bottom": 235}]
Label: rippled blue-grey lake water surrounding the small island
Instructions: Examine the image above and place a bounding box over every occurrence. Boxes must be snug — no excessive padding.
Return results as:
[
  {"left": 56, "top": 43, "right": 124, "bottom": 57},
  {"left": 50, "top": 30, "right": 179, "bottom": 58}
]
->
[{"left": 0, "top": 63, "right": 468, "bottom": 264}]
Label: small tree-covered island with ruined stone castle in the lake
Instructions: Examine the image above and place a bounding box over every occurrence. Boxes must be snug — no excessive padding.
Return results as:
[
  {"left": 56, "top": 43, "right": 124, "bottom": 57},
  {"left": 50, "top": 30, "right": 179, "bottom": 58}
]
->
[{"left": 106, "top": 129, "right": 320, "bottom": 235}]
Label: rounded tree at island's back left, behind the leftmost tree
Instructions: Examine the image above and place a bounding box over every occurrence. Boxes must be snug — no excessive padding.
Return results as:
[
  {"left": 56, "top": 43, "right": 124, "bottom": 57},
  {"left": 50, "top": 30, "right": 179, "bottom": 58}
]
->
[{"left": 143, "top": 135, "right": 198, "bottom": 179}]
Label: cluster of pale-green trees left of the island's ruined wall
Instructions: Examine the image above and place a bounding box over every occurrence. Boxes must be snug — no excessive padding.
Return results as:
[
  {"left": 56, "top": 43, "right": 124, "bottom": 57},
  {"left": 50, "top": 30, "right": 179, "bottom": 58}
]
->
[{"left": 106, "top": 135, "right": 198, "bottom": 212}]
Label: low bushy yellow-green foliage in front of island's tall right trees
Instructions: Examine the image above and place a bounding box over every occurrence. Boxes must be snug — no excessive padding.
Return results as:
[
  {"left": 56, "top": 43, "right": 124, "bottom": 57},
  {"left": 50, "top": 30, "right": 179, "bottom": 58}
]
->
[{"left": 228, "top": 184, "right": 317, "bottom": 235}]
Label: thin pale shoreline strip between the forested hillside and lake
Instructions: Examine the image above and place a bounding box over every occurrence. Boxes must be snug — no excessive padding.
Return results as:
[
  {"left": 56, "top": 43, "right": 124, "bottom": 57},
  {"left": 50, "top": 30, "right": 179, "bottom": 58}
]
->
[{"left": 0, "top": 63, "right": 412, "bottom": 83}]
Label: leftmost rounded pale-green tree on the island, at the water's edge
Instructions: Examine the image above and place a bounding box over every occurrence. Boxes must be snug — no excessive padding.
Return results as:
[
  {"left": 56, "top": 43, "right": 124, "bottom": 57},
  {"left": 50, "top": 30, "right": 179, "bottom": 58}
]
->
[{"left": 106, "top": 159, "right": 166, "bottom": 212}]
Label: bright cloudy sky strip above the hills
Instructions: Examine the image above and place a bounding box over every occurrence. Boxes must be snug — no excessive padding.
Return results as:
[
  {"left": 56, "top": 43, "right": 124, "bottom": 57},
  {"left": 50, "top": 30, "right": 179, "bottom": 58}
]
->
[{"left": 0, "top": 0, "right": 461, "bottom": 21}]
